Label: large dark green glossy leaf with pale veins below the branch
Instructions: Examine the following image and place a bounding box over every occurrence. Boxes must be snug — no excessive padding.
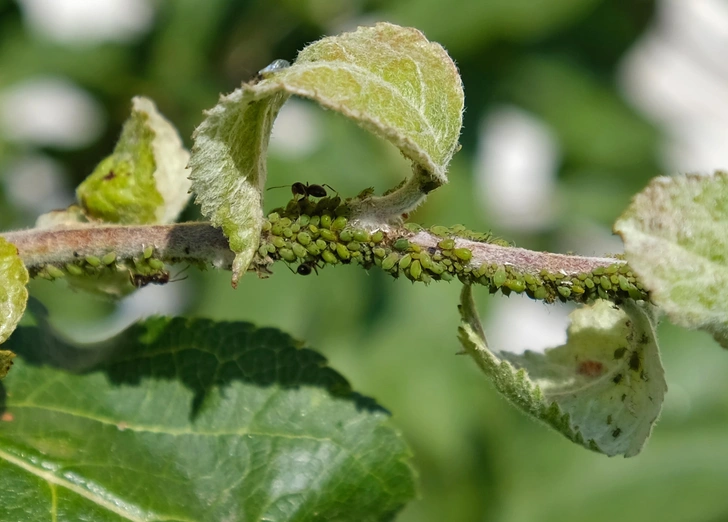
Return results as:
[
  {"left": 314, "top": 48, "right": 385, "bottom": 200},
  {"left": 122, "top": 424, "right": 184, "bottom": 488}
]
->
[{"left": 0, "top": 318, "right": 414, "bottom": 522}]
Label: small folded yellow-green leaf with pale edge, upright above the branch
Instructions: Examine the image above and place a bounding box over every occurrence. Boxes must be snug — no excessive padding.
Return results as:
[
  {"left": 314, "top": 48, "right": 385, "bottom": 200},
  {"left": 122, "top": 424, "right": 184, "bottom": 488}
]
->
[{"left": 76, "top": 97, "right": 190, "bottom": 224}]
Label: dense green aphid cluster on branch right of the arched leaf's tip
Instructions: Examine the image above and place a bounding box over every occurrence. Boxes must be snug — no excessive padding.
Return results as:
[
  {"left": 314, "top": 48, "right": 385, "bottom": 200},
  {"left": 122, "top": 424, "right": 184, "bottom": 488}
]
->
[{"left": 254, "top": 187, "right": 647, "bottom": 302}]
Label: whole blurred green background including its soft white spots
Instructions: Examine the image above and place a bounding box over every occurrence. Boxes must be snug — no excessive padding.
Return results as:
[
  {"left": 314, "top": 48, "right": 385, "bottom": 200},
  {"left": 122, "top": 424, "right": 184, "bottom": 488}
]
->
[{"left": 0, "top": 0, "right": 728, "bottom": 522}]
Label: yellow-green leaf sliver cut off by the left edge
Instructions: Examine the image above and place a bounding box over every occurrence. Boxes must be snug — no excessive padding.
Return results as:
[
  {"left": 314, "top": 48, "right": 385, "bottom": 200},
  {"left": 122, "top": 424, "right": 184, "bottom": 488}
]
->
[{"left": 0, "top": 237, "right": 28, "bottom": 348}]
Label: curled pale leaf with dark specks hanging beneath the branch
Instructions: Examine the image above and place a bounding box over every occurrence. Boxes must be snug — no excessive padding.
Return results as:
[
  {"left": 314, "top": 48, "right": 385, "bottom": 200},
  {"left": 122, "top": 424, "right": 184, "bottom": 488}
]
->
[{"left": 459, "top": 286, "right": 667, "bottom": 457}]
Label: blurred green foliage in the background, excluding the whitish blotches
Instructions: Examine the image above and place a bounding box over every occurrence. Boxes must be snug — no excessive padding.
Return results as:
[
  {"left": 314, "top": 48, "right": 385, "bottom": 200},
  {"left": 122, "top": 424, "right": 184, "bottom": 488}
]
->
[{"left": 0, "top": 0, "right": 728, "bottom": 522}]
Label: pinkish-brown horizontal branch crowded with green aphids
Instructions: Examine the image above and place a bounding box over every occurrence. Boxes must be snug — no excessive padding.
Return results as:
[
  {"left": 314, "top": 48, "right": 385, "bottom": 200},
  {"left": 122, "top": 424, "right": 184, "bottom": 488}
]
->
[{"left": 2, "top": 214, "right": 648, "bottom": 302}]
